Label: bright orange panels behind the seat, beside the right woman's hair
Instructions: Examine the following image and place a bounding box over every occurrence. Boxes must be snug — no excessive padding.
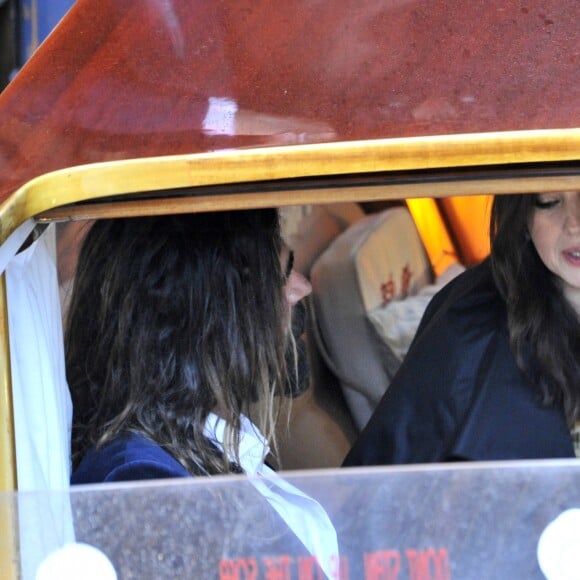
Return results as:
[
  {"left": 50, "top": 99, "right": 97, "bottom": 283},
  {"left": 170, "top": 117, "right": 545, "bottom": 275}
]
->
[{"left": 407, "top": 195, "right": 492, "bottom": 276}]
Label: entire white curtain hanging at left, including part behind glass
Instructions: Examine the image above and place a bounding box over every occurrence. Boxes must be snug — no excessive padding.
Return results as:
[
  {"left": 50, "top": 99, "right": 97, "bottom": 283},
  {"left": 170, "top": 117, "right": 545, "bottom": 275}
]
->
[{"left": 6, "top": 226, "right": 73, "bottom": 579}]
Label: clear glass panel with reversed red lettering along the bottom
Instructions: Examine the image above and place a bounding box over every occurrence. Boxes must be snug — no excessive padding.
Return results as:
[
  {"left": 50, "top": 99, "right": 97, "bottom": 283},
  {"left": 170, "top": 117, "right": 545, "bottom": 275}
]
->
[{"left": 0, "top": 460, "right": 580, "bottom": 580}]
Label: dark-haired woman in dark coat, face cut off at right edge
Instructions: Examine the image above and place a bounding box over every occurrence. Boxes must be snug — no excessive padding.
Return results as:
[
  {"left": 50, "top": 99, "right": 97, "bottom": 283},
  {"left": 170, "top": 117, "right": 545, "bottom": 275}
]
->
[{"left": 345, "top": 191, "right": 580, "bottom": 466}]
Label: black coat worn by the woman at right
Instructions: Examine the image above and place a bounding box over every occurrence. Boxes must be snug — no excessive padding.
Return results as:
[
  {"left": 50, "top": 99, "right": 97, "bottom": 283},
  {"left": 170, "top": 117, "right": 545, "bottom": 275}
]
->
[{"left": 344, "top": 261, "right": 574, "bottom": 466}]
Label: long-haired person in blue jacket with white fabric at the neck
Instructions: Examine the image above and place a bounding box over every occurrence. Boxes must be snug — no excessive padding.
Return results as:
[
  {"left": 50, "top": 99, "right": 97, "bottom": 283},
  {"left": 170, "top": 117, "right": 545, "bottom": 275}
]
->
[{"left": 66, "top": 209, "right": 336, "bottom": 570}]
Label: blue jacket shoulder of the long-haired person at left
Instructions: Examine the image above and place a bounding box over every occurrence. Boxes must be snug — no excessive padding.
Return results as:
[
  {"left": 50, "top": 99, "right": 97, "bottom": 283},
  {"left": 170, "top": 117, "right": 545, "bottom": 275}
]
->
[{"left": 71, "top": 433, "right": 190, "bottom": 485}]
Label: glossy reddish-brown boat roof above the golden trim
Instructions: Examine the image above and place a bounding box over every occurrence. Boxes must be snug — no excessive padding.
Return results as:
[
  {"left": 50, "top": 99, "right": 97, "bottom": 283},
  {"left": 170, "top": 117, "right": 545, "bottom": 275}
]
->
[{"left": 0, "top": 0, "right": 580, "bottom": 229}]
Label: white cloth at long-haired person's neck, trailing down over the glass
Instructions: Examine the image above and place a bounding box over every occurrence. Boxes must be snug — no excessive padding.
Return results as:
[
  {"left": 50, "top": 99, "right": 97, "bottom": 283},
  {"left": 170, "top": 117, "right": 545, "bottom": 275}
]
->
[{"left": 204, "top": 413, "right": 339, "bottom": 579}]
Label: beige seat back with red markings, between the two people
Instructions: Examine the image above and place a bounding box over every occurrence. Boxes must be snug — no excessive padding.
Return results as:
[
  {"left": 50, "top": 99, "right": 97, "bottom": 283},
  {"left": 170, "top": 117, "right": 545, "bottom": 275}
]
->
[{"left": 311, "top": 207, "right": 432, "bottom": 429}]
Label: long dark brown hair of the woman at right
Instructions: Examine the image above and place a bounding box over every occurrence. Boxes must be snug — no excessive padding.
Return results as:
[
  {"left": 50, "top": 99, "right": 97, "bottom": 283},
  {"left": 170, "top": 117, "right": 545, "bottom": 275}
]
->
[{"left": 490, "top": 194, "right": 580, "bottom": 426}]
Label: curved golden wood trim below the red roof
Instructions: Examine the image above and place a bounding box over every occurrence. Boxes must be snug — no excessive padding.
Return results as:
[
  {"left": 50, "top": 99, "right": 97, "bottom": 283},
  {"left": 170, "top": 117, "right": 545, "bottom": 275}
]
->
[{"left": 0, "top": 129, "right": 580, "bottom": 243}]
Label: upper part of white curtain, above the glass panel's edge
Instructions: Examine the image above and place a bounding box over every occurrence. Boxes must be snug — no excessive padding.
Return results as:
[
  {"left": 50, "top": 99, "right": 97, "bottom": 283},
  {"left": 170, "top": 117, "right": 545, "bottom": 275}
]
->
[{"left": 6, "top": 226, "right": 72, "bottom": 491}]
